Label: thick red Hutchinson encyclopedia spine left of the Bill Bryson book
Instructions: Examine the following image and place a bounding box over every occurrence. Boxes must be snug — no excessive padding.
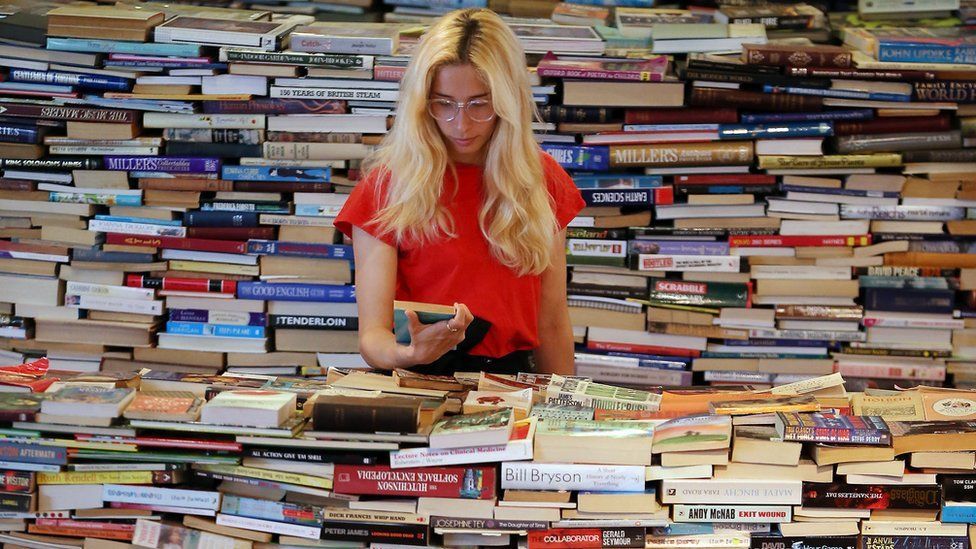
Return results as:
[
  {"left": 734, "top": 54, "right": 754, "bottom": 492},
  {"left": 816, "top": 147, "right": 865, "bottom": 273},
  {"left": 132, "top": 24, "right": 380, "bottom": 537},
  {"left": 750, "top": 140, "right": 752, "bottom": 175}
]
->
[{"left": 332, "top": 463, "right": 495, "bottom": 499}]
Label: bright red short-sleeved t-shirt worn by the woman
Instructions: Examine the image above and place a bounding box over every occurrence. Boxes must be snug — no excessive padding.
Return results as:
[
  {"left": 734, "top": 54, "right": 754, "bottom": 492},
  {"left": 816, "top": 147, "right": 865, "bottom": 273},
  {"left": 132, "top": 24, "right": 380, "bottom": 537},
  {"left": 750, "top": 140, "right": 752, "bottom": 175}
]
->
[{"left": 335, "top": 151, "right": 585, "bottom": 358}]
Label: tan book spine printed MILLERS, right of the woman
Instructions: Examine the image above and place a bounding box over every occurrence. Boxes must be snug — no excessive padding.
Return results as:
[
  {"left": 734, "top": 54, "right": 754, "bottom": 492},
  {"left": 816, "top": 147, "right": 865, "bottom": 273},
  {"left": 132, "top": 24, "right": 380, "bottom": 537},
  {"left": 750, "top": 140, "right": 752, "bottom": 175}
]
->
[{"left": 609, "top": 141, "right": 753, "bottom": 168}]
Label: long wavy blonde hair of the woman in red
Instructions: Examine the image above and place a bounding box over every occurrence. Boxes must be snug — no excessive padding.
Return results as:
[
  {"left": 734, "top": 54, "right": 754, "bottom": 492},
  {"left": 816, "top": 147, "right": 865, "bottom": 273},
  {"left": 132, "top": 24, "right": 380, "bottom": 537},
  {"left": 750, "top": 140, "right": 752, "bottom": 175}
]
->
[{"left": 362, "top": 8, "right": 558, "bottom": 276}]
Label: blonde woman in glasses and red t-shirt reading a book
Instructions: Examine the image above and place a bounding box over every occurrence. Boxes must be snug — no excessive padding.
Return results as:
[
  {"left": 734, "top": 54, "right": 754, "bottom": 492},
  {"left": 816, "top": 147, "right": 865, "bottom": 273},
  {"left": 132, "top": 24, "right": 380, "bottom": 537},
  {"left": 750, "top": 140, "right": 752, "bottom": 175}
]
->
[{"left": 335, "top": 9, "right": 584, "bottom": 374}]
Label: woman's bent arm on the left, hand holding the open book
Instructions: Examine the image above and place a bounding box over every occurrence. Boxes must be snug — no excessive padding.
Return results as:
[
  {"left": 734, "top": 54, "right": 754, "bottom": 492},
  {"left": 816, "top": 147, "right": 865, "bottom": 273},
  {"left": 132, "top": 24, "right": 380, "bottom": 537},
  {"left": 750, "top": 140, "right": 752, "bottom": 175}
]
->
[{"left": 352, "top": 226, "right": 474, "bottom": 370}]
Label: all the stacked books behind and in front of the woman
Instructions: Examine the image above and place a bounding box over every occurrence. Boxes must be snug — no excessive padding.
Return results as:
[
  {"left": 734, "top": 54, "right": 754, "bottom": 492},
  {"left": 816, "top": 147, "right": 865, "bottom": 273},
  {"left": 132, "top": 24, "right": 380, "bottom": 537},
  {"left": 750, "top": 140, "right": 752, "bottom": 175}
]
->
[{"left": 0, "top": 0, "right": 976, "bottom": 549}]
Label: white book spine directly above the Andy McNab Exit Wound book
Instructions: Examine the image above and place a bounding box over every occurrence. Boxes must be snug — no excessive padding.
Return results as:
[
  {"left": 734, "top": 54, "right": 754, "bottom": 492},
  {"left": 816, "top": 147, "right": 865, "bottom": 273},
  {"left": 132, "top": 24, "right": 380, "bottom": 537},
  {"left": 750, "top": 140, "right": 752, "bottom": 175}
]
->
[{"left": 661, "top": 479, "right": 803, "bottom": 505}]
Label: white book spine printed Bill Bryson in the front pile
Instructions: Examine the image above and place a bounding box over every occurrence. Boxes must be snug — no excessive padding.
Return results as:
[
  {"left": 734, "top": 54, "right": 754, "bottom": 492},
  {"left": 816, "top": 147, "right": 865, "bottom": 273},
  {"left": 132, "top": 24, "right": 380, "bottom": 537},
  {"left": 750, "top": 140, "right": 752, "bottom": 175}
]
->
[{"left": 501, "top": 462, "right": 645, "bottom": 492}]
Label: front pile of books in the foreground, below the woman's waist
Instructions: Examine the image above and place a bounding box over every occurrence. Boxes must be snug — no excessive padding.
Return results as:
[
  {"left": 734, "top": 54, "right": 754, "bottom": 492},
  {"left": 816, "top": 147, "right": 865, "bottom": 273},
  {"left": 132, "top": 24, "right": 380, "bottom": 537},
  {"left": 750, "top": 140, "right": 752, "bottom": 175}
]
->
[{"left": 0, "top": 362, "right": 976, "bottom": 549}]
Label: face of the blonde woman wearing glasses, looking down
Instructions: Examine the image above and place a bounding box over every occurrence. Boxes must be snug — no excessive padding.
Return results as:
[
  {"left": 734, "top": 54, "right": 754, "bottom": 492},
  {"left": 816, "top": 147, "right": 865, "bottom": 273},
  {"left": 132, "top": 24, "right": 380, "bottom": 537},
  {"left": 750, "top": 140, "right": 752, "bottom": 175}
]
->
[{"left": 428, "top": 65, "right": 498, "bottom": 164}]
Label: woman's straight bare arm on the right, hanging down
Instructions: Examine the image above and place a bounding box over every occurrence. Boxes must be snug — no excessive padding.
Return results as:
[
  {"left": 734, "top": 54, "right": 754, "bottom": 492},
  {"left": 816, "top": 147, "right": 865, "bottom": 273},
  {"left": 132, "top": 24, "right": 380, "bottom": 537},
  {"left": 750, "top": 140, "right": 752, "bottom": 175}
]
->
[{"left": 534, "top": 230, "right": 575, "bottom": 375}]
